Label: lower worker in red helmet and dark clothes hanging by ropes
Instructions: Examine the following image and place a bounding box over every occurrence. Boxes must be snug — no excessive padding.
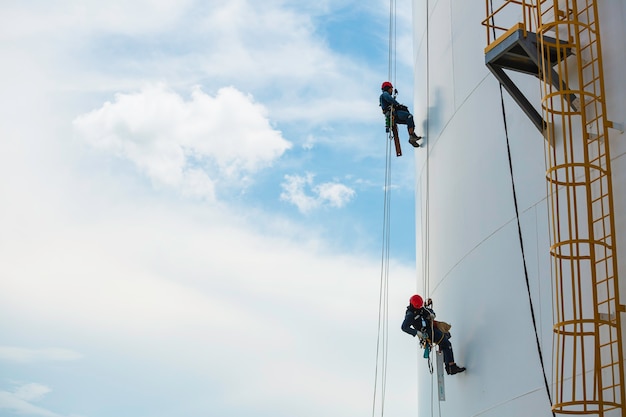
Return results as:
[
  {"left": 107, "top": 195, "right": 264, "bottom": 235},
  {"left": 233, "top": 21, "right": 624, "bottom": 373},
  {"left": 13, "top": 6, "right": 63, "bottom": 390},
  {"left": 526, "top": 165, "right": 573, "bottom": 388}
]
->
[{"left": 402, "top": 294, "right": 465, "bottom": 375}]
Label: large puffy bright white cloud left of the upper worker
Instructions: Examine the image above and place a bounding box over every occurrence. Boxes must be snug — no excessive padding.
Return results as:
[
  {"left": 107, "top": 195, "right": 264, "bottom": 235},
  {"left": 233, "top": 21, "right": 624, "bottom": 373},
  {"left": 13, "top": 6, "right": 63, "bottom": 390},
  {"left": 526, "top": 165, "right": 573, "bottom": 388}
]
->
[{"left": 74, "top": 84, "right": 291, "bottom": 200}]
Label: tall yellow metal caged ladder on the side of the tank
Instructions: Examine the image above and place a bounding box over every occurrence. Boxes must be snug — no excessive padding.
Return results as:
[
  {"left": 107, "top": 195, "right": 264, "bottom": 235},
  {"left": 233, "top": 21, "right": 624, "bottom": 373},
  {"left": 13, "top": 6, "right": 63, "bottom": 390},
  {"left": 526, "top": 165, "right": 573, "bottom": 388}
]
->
[{"left": 483, "top": 0, "right": 626, "bottom": 416}]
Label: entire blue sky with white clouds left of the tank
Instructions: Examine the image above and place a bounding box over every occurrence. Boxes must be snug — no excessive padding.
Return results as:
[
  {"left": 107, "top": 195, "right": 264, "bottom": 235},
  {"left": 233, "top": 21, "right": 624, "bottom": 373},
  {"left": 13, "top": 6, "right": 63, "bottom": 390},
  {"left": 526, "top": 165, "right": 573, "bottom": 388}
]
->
[{"left": 0, "top": 0, "right": 420, "bottom": 417}]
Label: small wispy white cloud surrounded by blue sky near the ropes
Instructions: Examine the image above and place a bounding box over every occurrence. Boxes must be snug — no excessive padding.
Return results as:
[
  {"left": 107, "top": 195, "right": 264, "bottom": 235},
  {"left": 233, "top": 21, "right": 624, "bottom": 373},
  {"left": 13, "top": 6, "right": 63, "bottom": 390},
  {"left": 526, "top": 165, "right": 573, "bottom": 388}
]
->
[{"left": 280, "top": 173, "right": 356, "bottom": 213}]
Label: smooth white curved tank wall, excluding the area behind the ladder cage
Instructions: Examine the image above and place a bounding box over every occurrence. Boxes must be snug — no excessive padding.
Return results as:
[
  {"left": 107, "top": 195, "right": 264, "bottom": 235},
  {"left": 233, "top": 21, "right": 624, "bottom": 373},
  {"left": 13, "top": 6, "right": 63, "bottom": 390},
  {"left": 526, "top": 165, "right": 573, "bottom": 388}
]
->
[{"left": 413, "top": 0, "right": 626, "bottom": 417}]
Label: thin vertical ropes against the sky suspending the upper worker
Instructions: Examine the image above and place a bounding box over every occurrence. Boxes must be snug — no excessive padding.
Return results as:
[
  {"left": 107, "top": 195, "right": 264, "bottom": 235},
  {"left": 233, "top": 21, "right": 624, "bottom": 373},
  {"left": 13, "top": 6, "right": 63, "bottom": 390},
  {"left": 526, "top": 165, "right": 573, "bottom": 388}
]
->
[{"left": 372, "top": 0, "right": 396, "bottom": 417}]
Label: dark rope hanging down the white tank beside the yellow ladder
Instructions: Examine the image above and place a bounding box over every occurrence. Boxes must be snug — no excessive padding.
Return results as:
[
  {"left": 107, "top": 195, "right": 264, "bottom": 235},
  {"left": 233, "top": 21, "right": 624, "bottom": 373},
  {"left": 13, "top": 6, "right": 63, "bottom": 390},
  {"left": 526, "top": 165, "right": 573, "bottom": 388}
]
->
[{"left": 490, "top": 0, "right": 556, "bottom": 417}]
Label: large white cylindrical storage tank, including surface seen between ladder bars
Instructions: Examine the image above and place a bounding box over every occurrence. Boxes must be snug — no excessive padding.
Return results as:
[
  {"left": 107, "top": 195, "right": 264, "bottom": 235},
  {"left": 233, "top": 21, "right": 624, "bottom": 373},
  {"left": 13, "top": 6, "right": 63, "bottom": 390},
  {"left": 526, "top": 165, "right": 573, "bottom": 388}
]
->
[{"left": 413, "top": 0, "right": 626, "bottom": 417}]
